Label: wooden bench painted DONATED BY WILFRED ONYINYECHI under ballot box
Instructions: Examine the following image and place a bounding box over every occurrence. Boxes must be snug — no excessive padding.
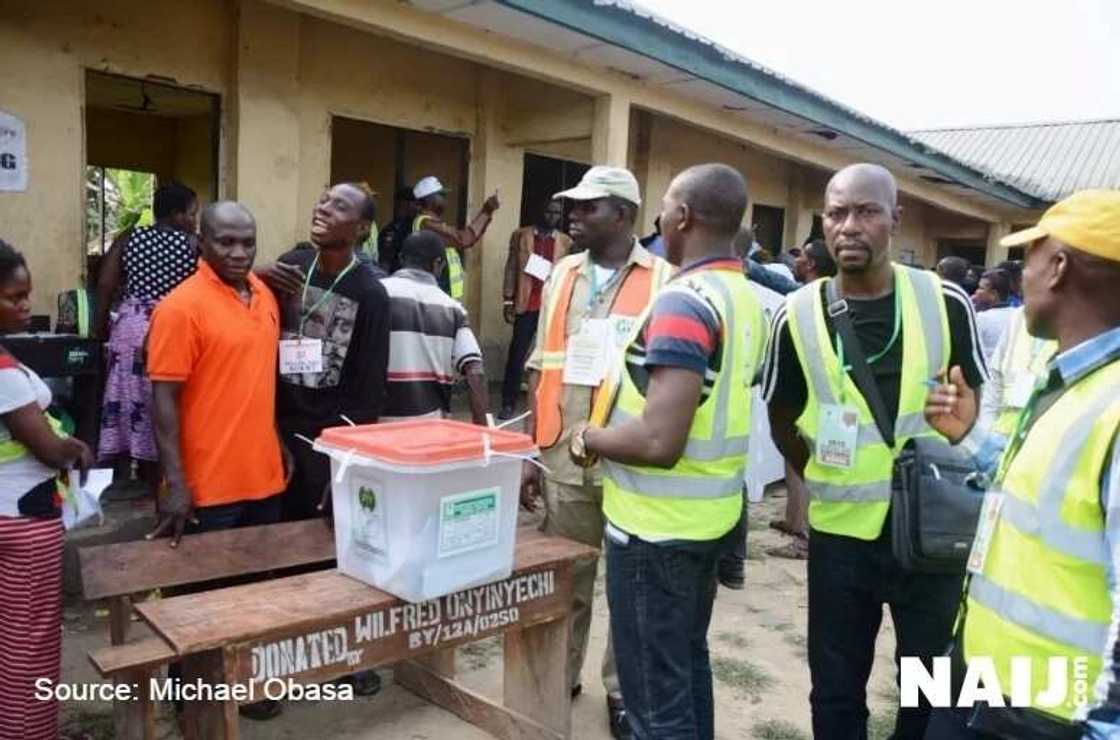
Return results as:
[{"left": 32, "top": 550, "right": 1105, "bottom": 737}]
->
[{"left": 91, "top": 527, "right": 597, "bottom": 740}]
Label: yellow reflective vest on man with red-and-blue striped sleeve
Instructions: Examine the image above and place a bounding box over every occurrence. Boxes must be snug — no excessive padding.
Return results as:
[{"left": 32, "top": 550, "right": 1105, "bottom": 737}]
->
[{"left": 603, "top": 270, "right": 766, "bottom": 541}]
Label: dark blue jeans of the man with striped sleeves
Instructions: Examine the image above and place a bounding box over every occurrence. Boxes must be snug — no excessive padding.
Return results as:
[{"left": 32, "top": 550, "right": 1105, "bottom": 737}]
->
[{"left": 606, "top": 526, "right": 727, "bottom": 740}]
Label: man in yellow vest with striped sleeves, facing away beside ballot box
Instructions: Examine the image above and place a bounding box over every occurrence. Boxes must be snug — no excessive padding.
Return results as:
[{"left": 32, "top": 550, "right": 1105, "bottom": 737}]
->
[{"left": 571, "top": 165, "right": 766, "bottom": 740}]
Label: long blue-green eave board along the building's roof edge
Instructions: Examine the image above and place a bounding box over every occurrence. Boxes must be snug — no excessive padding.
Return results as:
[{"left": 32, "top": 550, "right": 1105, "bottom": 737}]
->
[{"left": 495, "top": 0, "right": 1048, "bottom": 209}]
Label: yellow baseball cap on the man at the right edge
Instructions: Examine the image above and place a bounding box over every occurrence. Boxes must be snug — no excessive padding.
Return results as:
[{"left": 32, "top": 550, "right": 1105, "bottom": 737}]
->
[{"left": 999, "top": 190, "right": 1120, "bottom": 262}]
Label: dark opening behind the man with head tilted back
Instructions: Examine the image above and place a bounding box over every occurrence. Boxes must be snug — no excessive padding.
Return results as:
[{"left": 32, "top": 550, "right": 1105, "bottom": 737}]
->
[{"left": 330, "top": 116, "right": 470, "bottom": 236}]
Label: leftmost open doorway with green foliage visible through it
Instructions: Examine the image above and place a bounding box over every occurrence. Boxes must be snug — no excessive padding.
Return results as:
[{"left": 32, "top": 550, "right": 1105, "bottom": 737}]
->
[{"left": 85, "top": 71, "right": 221, "bottom": 277}]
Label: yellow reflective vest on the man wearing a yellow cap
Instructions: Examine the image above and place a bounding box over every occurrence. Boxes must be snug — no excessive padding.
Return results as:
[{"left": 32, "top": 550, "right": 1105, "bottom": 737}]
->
[{"left": 963, "top": 360, "right": 1120, "bottom": 720}]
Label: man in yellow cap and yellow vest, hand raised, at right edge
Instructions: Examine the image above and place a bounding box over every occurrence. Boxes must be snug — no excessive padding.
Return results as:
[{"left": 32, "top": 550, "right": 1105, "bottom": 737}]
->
[{"left": 926, "top": 190, "right": 1120, "bottom": 740}]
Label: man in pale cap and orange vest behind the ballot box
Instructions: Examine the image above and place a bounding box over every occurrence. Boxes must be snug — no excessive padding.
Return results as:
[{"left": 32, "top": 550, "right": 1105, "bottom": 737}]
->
[{"left": 522, "top": 167, "right": 672, "bottom": 738}]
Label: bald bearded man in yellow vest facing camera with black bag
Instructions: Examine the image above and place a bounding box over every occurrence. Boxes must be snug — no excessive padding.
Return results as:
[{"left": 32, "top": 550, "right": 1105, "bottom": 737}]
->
[{"left": 763, "top": 165, "right": 987, "bottom": 739}]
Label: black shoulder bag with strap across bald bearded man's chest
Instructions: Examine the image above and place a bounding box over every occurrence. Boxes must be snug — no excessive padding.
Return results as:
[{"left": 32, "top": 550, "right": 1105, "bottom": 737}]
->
[{"left": 827, "top": 280, "right": 983, "bottom": 573}]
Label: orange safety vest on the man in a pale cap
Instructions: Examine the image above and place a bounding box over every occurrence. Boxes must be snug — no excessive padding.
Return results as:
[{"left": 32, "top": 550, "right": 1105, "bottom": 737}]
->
[{"left": 536, "top": 257, "right": 672, "bottom": 449}]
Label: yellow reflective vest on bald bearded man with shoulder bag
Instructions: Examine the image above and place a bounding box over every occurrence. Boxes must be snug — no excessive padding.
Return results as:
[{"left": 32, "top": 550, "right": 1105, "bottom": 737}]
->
[{"left": 786, "top": 264, "right": 951, "bottom": 540}]
